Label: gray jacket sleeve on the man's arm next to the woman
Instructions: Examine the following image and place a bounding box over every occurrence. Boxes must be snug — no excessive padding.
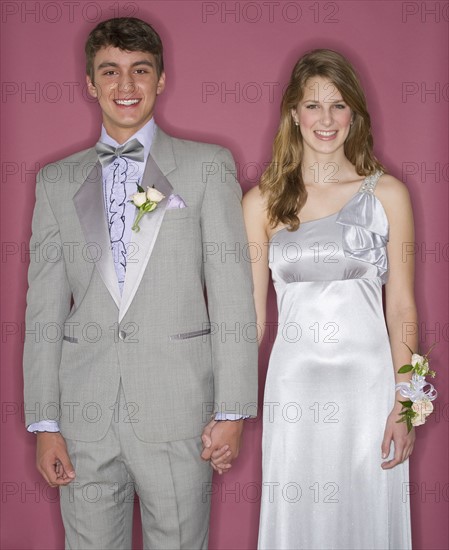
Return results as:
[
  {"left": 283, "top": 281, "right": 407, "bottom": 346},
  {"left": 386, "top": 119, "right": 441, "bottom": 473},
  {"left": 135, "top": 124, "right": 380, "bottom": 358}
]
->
[{"left": 201, "top": 149, "right": 258, "bottom": 416}]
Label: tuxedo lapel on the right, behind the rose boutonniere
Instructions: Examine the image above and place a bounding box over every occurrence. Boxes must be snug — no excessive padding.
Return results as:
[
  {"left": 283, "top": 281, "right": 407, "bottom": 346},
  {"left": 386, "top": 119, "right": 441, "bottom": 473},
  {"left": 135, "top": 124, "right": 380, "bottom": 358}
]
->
[{"left": 119, "top": 129, "right": 176, "bottom": 322}]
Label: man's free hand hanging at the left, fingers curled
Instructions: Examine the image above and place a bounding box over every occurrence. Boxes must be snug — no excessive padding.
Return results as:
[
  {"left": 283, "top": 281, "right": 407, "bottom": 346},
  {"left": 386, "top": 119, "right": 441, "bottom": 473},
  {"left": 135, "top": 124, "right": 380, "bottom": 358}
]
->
[{"left": 36, "top": 432, "right": 75, "bottom": 487}]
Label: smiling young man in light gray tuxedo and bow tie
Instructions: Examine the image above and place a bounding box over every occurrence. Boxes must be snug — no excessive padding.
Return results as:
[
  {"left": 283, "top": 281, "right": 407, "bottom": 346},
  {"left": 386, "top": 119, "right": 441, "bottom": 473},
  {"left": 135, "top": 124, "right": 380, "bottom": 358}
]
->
[{"left": 24, "top": 18, "right": 257, "bottom": 550}]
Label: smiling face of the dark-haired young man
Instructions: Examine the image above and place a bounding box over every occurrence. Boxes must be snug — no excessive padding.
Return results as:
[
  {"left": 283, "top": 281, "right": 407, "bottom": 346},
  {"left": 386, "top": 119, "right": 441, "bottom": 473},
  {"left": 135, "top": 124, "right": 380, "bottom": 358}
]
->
[{"left": 86, "top": 46, "right": 165, "bottom": 143}]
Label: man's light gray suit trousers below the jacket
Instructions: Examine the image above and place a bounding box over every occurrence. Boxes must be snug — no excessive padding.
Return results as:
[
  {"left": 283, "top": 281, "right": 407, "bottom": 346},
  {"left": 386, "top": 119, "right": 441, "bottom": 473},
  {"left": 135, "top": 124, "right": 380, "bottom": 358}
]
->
[{"left": 61, "top": 388, "right": 211, "bottom": 550}]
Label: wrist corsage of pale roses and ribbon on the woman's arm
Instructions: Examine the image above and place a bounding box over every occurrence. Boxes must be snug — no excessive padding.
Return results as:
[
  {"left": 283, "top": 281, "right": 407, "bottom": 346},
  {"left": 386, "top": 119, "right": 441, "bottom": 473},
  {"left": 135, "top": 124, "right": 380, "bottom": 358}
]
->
[{"left": 396, "top": 344, "right": 437, "bottom": 431}]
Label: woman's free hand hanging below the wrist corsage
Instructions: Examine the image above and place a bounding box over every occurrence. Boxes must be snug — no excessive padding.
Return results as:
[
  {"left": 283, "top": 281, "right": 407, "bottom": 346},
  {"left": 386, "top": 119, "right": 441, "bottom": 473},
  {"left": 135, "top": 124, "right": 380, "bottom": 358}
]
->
[{"left": 381, "top": 407, "right": 415, "bottom": 470}]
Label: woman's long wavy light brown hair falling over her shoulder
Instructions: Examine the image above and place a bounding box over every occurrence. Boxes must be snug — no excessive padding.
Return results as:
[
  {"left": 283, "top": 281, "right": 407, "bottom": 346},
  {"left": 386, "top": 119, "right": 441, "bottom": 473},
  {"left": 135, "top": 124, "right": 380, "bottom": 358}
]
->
[{"left": 260, "top": 49, "right": 385, "bottom": 231}]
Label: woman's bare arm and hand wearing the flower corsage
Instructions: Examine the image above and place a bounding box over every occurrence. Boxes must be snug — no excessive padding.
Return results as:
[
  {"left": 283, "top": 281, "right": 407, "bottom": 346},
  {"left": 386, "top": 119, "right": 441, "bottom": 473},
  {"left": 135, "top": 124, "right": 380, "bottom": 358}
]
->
[{"left": 376, "top": 176, "right": 418, "bottom": 469}]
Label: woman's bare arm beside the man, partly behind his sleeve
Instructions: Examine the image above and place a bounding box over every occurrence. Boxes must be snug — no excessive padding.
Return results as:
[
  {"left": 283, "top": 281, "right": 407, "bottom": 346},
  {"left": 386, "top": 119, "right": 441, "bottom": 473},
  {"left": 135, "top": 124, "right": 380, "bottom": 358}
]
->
[{"left": 243, "top": 187, "right": 269, "bottom": 344}]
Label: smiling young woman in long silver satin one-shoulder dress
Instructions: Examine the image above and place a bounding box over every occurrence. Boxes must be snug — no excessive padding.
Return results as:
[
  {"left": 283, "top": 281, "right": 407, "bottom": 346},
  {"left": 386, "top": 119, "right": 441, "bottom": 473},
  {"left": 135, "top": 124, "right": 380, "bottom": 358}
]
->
[{"left": 244, "top": 50, "right": 417, "bottom": 550}]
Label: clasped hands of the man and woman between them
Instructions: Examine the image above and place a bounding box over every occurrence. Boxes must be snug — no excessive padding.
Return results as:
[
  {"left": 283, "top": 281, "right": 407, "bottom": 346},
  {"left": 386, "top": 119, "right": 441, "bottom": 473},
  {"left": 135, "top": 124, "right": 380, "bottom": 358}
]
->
[{"left": 201, "top": 419, "right": 244, "bottom": 475}]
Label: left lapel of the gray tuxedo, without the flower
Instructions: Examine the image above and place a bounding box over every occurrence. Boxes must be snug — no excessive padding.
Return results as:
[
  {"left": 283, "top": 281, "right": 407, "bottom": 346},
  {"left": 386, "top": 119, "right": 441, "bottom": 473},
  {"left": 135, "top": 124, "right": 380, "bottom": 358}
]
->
[{"left": 73, "top": 162, "right": 121, "bottom": 307}]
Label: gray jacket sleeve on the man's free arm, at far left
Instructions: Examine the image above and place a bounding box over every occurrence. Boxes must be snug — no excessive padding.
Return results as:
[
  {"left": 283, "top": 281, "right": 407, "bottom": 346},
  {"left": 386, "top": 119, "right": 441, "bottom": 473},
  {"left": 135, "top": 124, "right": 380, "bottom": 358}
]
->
[{"left": 23, "top": 168, "right": 71, "bottom": 426}]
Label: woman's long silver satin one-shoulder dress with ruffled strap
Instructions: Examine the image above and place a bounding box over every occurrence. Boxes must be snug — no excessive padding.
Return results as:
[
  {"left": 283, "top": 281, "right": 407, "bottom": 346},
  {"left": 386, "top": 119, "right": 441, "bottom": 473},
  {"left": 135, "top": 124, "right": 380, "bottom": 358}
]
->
[{"left": 259, "top": 173, "right": 411, "bottom": 550}]
